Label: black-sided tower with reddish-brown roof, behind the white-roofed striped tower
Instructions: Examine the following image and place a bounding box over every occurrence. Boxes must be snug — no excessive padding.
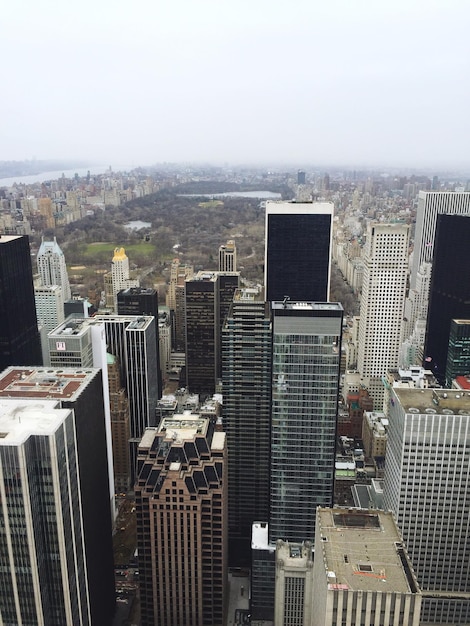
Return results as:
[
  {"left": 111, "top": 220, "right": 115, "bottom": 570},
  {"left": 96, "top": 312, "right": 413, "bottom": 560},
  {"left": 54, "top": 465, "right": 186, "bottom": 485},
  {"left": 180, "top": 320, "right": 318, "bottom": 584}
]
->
[{"left": 0, "top": 366, "right": 115, "bottom": 626}]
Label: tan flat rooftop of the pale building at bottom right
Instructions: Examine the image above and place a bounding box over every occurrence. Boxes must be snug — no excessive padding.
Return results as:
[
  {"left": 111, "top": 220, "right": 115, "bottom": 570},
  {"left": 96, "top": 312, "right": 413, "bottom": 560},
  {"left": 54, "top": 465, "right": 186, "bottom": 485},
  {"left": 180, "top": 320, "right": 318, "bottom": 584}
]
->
[{"left": 315, "top": 507, "right": 417, "bottom": 593}]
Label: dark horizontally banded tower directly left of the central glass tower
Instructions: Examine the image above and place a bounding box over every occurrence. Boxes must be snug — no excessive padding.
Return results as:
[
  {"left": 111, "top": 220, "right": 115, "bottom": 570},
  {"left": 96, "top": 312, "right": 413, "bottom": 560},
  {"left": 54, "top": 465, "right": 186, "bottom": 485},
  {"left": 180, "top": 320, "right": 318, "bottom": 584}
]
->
[{"left": 222, "top": 288, "right": 272, "bottom": 565}]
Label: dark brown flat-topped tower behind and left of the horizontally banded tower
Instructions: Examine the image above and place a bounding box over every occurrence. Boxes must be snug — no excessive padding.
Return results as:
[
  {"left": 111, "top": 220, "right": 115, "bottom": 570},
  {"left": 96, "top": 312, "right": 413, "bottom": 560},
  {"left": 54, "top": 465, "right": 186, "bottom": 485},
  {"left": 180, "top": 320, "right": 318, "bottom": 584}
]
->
[{"left": 186, "top": 271, "right": 239, "bottom": 395}]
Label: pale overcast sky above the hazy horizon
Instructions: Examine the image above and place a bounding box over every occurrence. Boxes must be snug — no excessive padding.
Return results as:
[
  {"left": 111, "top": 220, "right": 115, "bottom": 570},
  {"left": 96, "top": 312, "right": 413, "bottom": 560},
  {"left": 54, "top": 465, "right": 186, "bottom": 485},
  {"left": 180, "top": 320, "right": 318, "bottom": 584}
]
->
[{"left": 0, "top": 0, "right": 470, "bottom": 170}]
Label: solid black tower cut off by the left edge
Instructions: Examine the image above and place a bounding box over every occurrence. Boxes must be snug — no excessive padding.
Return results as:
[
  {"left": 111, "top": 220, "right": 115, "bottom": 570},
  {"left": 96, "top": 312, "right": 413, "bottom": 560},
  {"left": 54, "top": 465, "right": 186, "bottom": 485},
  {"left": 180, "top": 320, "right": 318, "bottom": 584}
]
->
[{"left": 0, "top": 235, "right": 42, "bottom": 371}]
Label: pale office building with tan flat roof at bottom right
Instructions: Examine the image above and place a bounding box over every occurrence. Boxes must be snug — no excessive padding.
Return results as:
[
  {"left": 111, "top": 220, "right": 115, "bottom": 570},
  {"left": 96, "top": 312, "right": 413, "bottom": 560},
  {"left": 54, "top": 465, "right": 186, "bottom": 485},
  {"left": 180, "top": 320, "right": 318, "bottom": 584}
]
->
[{"left": 312, "top": 507, "right": 421, "bottom": 626}]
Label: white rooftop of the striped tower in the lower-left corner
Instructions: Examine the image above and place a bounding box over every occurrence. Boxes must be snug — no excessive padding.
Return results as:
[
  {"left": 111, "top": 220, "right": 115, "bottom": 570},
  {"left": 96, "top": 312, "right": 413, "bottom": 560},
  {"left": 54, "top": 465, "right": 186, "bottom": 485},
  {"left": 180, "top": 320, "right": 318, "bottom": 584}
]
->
[{"left": 0, "top": 400, "right": 70, "bottom": 446}]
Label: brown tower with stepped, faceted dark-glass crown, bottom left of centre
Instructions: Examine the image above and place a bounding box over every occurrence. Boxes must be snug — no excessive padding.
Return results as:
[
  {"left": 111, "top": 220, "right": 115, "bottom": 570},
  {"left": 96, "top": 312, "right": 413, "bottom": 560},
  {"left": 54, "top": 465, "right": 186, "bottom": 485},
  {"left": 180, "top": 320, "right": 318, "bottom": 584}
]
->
[{"left": 135, "top": 412, "right": 227, "bottom": 626}]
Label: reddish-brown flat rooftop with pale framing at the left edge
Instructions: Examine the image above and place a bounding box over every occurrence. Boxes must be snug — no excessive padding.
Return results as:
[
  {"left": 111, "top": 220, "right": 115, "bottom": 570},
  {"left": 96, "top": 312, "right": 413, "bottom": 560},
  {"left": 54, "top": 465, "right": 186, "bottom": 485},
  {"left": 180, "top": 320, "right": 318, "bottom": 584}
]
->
[{"left": 0, "top": 366, "right": 99, "bottom": 400}]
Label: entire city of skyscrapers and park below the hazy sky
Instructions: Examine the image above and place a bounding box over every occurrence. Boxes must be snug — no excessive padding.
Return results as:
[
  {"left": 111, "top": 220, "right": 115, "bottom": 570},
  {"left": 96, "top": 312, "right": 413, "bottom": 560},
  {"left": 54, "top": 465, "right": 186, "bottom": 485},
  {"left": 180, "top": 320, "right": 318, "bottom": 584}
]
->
[{"left": 0, "top": 165, "right": 470, "bottom": 626}]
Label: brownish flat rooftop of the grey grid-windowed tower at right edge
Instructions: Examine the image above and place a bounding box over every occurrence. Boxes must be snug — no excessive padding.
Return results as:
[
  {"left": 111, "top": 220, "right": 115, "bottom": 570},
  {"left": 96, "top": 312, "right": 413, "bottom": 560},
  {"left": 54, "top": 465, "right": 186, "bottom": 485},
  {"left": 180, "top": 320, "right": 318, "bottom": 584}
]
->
[{"left": 393, "top": 388, "right": 470, "bottom": 416}]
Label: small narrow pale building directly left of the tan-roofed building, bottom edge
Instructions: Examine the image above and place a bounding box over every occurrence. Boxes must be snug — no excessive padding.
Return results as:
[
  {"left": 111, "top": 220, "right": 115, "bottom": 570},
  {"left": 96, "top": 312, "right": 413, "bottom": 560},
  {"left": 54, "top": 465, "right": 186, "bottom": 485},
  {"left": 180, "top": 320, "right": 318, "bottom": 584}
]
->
[{"left": 274, "top": 539, "right": 314, "bottom": 626}]
